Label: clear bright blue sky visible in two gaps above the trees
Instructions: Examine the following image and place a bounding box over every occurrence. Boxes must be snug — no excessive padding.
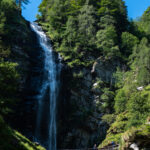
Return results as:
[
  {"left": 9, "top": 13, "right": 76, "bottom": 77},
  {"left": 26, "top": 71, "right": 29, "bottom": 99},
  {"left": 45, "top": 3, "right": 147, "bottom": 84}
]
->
[{"left": 22, "top": 0, "right": 150, "bottom": 21}]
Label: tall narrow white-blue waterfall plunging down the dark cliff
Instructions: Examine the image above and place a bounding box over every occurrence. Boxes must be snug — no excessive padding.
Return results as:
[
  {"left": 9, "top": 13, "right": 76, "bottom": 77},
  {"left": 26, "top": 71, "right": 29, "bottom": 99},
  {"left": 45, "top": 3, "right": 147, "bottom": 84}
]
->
[{"left": 30, "top": 23, "right": 61, "bottom": 150}]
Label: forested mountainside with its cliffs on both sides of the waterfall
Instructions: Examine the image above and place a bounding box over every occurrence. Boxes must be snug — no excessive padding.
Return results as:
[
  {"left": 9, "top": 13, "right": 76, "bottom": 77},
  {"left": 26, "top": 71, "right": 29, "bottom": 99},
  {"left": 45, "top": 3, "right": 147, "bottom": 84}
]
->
[{"left": 0, "top": 0, "right": 150, "bottom": 150}]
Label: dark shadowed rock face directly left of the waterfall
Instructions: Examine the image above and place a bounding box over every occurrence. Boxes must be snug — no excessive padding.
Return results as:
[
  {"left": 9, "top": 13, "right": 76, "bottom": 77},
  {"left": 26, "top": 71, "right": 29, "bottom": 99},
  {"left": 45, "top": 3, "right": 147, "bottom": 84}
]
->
[{"left": 10, "top": 21, "right": 43, "bottom": 139}]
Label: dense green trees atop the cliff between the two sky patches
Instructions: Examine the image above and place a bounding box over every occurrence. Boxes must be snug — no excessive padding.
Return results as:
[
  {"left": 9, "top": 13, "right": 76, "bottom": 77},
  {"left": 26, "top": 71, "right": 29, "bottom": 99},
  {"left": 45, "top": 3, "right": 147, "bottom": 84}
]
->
[{"left": 38, "top": 0, "right": 128, "bottom": 67}]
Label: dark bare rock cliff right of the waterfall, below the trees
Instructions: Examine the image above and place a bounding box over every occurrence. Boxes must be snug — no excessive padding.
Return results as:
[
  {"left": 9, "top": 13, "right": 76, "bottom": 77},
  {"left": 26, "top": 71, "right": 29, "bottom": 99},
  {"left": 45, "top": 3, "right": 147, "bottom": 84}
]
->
[{"left": 58, "top": 58, "right": 120, "bottom": 148}]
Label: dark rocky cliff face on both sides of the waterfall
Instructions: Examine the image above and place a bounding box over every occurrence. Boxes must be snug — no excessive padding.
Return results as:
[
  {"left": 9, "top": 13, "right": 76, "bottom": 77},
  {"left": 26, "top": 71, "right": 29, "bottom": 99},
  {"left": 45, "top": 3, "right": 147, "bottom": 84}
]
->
[{"left": 9, "top": 19, "right": 120, "bottom": 148}]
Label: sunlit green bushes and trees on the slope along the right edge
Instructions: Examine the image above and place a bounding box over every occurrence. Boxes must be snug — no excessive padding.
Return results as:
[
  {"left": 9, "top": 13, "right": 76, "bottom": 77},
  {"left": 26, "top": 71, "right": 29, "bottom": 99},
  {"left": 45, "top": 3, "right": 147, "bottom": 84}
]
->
[{"left": 100, "top": 5, "right": 150, "bottom": 149}]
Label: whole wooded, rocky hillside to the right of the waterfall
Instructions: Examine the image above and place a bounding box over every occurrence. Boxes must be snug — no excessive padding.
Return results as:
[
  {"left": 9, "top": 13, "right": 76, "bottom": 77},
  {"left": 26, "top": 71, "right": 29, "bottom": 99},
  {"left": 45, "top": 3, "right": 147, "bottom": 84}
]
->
[{"left": 37, "top": 0, "right": 150, "bottom": 149}]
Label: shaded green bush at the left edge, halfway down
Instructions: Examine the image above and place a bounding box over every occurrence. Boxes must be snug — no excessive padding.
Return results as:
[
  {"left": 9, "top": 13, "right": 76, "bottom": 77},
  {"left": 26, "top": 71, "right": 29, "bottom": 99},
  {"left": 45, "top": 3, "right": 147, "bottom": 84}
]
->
[{"left": 0, "top": 60, "right": 19, "bottom": 114}]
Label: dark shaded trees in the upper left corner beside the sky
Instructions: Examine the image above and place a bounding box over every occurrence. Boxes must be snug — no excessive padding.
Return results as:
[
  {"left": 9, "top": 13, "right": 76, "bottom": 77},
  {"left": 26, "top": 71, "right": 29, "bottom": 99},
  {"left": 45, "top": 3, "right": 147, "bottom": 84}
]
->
[{"left": 0, "top": 0, "right": 29, "bottom": 46}]
